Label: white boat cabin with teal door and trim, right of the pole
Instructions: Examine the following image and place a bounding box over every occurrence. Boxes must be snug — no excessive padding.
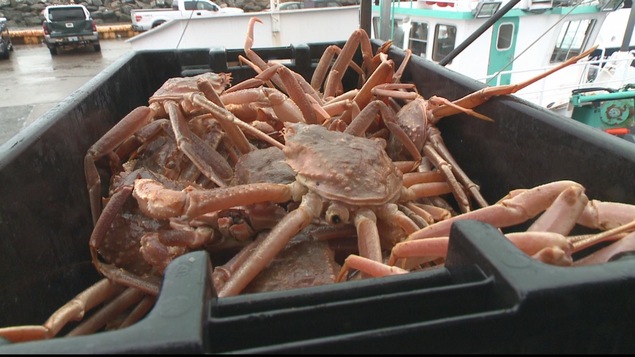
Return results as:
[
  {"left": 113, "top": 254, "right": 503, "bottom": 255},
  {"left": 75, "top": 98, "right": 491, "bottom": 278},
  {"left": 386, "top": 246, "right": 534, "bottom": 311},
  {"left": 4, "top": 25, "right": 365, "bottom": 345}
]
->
[{"left": 372, "top": 0, "right": 635, "bottom": 116}]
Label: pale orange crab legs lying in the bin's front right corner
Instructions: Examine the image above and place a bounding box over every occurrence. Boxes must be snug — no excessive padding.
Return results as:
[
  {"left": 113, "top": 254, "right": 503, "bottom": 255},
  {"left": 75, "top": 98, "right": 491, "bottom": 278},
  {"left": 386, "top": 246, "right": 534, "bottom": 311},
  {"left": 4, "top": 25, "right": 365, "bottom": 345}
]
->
[{"left": 338, "top": 180, "right": 635, "bottom": 281}]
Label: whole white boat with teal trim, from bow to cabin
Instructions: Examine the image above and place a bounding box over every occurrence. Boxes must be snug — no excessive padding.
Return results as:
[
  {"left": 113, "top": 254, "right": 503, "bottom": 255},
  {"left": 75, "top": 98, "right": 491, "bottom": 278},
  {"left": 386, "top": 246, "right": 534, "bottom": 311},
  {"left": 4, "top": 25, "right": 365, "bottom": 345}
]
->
[{"left": 128, "top": 0, "right": 635, "bottom": 126}]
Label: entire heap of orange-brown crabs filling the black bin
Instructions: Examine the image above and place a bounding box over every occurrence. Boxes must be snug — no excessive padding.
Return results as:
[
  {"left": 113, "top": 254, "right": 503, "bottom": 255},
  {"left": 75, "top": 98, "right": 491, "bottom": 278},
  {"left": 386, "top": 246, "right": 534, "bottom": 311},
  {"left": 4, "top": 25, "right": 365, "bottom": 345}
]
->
[{"left": 0, "top": 19, "right": 635, "bottom": 341}]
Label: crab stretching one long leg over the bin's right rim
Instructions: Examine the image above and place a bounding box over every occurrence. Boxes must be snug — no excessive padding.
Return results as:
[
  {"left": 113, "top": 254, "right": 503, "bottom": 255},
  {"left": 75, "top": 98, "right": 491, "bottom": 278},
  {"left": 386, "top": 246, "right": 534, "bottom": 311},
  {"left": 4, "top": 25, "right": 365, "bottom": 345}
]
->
[{"left": 356, "top": 42, "right": 595, "bottom": 212}]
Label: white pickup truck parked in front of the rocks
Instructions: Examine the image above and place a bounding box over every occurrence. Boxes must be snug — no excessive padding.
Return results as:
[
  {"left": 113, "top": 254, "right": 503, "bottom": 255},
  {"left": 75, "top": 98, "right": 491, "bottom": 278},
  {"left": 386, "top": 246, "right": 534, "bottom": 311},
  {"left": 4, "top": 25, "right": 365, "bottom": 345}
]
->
[{"left": 130, "top": 0, "right": 244, "bottom": 32}]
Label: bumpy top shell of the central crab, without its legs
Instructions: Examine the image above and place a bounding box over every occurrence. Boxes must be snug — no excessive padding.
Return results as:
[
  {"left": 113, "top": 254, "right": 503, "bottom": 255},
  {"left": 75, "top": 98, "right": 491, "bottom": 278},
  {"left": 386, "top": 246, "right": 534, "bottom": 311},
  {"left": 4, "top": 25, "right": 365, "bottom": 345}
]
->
[{"left": 284, "top": 123, "right": 402, "bottom": 206}]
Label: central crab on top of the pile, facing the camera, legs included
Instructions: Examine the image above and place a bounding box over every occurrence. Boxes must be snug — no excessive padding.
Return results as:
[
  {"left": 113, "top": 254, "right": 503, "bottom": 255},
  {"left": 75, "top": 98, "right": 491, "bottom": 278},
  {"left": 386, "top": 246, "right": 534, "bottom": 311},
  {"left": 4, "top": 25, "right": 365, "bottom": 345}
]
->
[{"left": 133, "top": 123, "right": 458, "bottom": 297}]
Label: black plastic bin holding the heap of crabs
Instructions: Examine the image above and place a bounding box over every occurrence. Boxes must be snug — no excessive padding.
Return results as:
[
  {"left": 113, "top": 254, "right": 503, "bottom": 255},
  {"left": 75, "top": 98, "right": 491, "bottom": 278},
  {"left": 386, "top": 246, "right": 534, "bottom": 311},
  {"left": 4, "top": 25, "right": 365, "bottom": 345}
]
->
[{"left": 0, "top": 42, "right": 635, "bottom": 354}]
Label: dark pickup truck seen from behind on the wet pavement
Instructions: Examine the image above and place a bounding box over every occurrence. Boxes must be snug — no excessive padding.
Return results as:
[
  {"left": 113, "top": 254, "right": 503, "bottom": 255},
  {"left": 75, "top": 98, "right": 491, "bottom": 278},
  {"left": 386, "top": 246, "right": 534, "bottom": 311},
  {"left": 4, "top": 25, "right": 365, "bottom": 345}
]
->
[{"left": 42, "top": 4, "right": 101, "bottom": 56}]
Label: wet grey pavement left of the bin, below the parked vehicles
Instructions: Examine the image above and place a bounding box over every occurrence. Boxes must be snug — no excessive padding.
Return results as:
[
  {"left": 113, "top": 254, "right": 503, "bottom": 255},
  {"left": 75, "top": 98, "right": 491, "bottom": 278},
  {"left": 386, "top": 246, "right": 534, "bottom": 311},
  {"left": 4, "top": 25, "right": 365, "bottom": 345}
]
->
[{"left": 0, "top": 39, "right": 132, "bottom": 144}]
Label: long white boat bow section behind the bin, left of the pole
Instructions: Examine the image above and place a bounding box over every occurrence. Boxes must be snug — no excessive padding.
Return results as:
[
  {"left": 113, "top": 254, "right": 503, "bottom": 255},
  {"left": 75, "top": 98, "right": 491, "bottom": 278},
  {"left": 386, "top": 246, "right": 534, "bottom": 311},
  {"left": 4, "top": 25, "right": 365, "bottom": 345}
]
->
[{"left": 127, "top": 5, "right": 359, "bottom": 51}]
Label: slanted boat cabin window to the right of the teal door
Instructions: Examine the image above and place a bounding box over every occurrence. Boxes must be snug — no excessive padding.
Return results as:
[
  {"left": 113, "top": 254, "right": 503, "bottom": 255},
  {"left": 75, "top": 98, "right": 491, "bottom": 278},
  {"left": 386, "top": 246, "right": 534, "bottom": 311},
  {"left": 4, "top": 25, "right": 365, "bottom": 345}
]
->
[{"left": 551, "top": 19, "right": 596, "bottom": 63}]
